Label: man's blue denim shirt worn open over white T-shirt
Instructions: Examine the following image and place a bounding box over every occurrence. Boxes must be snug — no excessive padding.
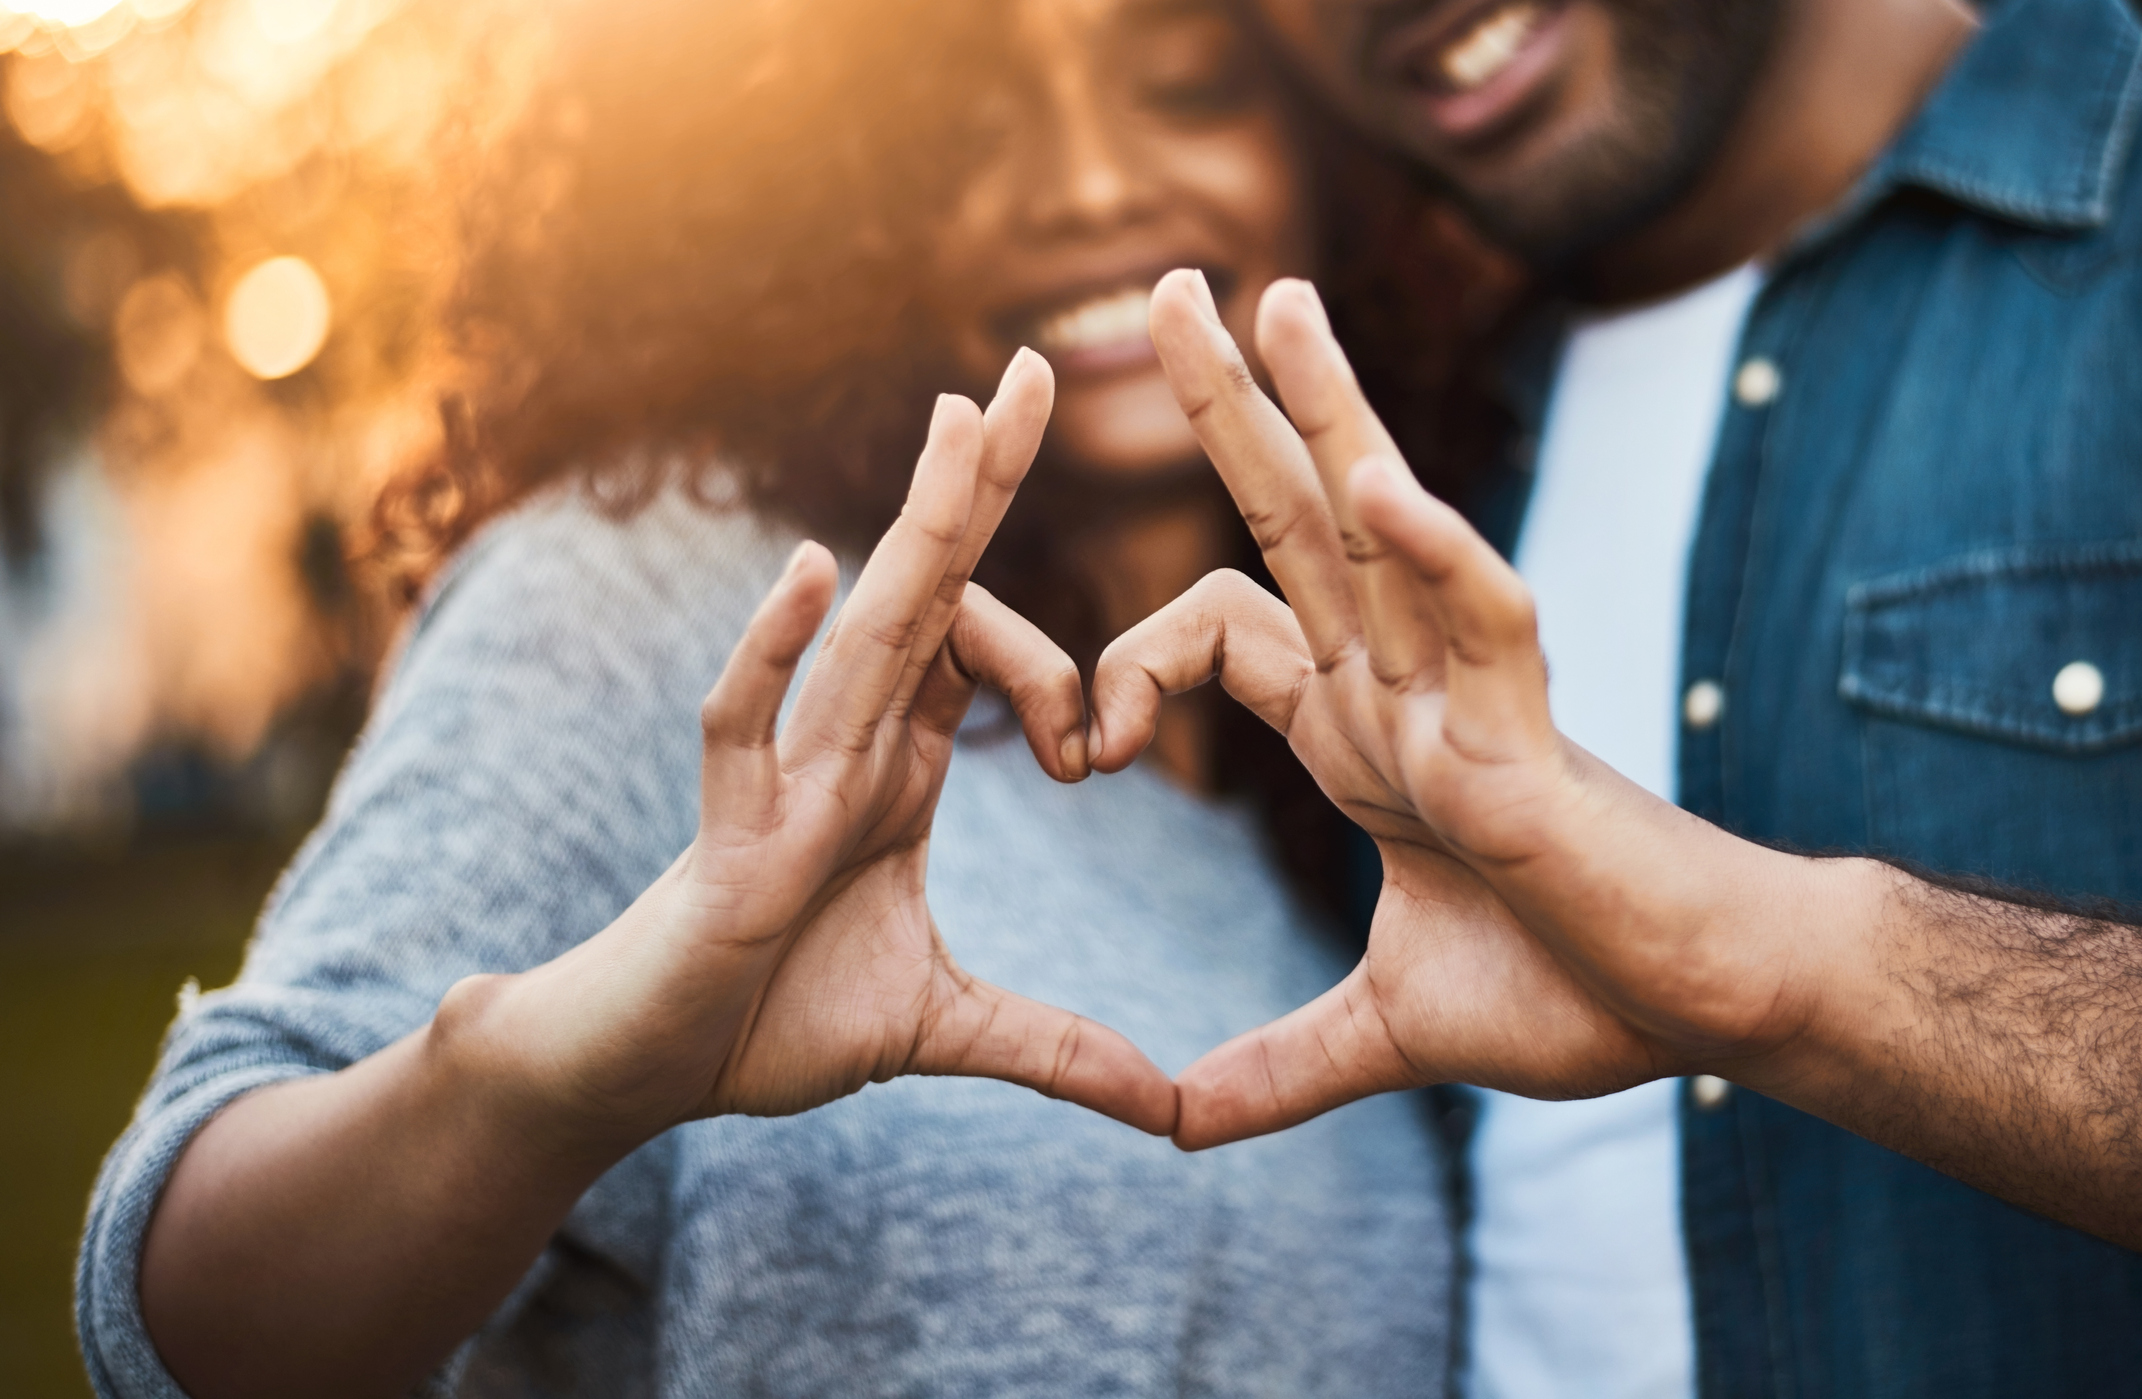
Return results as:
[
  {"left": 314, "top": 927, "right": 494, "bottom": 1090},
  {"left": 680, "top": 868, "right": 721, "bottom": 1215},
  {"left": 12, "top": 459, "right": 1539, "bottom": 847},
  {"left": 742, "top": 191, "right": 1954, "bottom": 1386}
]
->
[{"left": 1474, "top": 0, "right": 2142, "bottom": 1399}]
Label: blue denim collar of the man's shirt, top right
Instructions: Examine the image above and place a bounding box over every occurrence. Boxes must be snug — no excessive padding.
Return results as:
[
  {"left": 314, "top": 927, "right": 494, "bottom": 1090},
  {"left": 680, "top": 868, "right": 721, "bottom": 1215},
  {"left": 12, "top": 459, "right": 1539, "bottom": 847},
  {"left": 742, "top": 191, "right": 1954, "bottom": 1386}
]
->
[{"left": 1851, "top": 0, "right": 2142, "bottom": 231}]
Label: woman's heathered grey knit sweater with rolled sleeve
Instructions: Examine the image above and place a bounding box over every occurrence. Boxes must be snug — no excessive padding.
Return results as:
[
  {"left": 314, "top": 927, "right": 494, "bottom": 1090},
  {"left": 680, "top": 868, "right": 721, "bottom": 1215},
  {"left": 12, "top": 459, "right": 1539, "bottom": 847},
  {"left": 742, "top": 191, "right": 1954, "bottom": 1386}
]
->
[{"left": 77, "top": 482, "right": 1452, "bottom": 1399}]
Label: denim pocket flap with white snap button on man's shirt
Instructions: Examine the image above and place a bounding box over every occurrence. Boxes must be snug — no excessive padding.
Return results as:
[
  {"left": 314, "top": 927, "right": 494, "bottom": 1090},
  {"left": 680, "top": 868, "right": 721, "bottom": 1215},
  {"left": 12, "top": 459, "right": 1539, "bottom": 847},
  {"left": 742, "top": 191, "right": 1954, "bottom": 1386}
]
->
[{"left": 1838, "top": 540, "right": 2142, "bottom": 754}]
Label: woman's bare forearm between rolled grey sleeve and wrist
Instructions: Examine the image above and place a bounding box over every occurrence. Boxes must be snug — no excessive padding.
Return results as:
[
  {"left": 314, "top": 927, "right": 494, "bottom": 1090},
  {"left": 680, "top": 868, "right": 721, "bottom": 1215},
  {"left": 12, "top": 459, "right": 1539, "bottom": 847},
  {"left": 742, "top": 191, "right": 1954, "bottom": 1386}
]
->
[{"left": 141, "top": 977, "right": 630, "bottom": 1399}]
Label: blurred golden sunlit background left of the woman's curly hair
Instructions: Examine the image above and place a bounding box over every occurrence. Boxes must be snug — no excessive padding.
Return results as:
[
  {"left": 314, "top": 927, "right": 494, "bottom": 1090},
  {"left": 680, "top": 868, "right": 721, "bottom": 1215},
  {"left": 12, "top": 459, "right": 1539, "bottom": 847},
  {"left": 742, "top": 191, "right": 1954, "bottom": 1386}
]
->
[{"left": 0, "top": 0, "right": 518, "bottom": 836}]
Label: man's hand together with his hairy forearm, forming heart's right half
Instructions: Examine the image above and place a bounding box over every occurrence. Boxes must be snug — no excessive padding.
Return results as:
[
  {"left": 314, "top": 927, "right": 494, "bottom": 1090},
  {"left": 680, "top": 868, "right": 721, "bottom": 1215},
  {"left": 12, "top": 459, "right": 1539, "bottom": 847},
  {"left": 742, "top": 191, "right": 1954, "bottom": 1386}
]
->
[{"left": 1092, "top": 272, "right": 2142, "bottom": 1247}]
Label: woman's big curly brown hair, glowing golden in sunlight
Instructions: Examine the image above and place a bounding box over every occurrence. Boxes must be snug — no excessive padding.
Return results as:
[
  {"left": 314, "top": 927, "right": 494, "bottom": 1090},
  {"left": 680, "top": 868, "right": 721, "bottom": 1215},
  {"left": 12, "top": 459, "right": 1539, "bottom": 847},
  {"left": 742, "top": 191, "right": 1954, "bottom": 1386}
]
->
[{"left": 375, "top": 0, "right": 1512, "bottom": 916}]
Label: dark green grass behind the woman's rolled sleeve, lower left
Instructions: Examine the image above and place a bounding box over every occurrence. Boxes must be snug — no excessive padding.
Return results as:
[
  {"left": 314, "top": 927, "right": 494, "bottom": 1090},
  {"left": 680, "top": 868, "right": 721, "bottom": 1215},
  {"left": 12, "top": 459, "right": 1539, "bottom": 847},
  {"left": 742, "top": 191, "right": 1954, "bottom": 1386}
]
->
[{"left": 0, "top": 840, "right": 289, "bottom": 1399}]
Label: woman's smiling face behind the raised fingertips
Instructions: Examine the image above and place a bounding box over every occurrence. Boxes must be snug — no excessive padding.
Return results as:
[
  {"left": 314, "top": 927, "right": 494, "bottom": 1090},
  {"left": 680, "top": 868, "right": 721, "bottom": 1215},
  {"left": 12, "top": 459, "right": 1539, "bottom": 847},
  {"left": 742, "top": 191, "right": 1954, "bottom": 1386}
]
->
[{"left": 934, "top": 0, "right": 1311, "bottom": 478}]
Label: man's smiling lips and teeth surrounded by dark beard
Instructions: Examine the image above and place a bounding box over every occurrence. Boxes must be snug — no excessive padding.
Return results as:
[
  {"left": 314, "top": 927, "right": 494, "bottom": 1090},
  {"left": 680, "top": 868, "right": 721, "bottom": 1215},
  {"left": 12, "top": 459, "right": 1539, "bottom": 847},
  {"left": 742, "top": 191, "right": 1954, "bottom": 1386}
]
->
[{"left": 1390, "top": 0, "right": 1568, "bottom": 141}]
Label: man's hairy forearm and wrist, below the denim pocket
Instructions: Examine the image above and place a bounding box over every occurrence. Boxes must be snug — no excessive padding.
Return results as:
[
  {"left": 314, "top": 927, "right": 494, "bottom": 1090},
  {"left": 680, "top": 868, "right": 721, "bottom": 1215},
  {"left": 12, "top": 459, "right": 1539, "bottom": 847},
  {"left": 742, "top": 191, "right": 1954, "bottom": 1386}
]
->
[{"left": 1487, "top": 754, "right": 2142, "bottom": 1247}]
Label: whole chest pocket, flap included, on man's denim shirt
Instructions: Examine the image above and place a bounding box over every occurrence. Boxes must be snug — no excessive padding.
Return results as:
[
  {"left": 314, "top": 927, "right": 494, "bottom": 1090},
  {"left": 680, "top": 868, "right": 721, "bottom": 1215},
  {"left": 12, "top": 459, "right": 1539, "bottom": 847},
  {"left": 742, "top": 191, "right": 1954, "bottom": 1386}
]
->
[{"left": 1838, "top": 540, "right": 2142, "bottom": 900}]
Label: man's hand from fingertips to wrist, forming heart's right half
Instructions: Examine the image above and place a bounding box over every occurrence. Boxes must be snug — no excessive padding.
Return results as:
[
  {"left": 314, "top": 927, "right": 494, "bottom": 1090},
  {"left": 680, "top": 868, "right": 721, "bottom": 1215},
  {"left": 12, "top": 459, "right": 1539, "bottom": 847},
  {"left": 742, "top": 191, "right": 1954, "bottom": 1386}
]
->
[{"left": 1092, "top": 272, "right": 1842, "bottom": 1146}]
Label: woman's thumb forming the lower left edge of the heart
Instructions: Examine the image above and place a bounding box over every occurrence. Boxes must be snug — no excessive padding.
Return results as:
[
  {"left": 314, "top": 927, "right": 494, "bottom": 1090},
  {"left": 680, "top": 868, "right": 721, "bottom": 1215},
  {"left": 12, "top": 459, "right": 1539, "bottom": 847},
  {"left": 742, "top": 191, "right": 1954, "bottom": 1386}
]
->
[{"left": 906, "top": 971, "right": 1176, "bottom": 1138}]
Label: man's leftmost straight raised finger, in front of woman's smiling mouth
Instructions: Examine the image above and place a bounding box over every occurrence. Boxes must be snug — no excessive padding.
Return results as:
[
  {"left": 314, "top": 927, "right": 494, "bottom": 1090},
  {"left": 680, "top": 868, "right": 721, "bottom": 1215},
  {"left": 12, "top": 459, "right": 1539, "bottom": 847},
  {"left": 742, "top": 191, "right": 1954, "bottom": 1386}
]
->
[{"left": 1152, "top": 270, "right": 1360, "bottom": 666}]
